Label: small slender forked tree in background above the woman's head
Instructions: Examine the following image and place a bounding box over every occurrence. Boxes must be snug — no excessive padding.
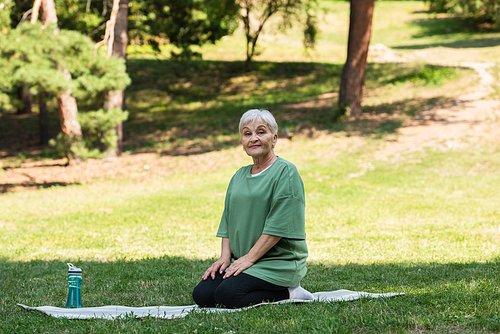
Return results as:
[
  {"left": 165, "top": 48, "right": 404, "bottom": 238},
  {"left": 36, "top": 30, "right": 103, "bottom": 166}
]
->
[{"left": 236, "top": 0, "right": 317, "bottom": 70}]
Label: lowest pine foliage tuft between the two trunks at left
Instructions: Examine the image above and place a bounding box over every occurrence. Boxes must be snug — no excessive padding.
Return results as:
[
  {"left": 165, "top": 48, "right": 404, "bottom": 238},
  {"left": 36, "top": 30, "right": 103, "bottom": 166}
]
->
[{"left": 78, "top": 108, "right": 128, "bottom": 152}]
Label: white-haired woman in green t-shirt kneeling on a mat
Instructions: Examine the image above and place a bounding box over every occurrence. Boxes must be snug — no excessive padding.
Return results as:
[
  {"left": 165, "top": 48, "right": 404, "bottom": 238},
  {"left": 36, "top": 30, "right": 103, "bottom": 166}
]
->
[{"left": 193, "top": 109, "right": 313, "bottom": 308}]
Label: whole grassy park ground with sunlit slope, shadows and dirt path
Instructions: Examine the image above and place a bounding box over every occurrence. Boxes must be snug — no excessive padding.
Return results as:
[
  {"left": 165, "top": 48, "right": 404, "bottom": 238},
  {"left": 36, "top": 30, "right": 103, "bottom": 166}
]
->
[{"left": 0, "top": 1, "right": 500, "bottom": 333}]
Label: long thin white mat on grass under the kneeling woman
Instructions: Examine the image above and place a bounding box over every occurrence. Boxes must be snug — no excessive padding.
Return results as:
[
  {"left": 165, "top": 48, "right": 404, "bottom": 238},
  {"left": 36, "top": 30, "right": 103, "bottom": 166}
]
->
[{"left": 17, "top": 290, "right": 404, "bottom": 320}]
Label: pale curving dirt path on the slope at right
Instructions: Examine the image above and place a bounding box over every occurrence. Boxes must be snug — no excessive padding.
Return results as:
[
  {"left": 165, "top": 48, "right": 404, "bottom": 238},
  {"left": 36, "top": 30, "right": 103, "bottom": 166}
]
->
[{"left": 374, "top": 45, "right": 500, "bottom": 160}]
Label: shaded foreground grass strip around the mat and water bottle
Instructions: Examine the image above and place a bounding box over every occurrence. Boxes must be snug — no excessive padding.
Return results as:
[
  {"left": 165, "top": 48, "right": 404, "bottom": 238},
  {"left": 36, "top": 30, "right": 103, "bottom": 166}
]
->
[{"left": 0, "top": 256, "right": 500, "bottom": 333}]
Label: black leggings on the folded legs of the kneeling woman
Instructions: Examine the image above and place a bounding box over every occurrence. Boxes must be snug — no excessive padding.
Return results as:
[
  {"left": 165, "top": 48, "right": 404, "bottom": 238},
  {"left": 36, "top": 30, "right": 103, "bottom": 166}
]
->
[{"left": 193, "top": 273, "right": 290, "bottom": 308}]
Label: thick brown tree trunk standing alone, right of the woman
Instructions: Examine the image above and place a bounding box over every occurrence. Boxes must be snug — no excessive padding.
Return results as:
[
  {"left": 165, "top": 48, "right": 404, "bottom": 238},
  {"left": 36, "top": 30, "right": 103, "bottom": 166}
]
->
[{"left": 339, "top": 0, "right": 374, "bottom": 117}]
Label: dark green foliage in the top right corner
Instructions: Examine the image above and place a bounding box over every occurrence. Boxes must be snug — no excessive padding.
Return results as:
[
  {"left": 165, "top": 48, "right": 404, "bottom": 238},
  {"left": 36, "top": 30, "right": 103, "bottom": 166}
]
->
[{"left": 426, "top": 0, "right": 500, "bottom": 29}]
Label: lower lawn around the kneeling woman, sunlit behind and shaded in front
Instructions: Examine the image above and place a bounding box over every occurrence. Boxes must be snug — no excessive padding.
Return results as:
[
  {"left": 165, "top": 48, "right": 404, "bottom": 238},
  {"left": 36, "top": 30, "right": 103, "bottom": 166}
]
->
[{"left": 0, "top": 136, "right": 500, "bottom": 333}]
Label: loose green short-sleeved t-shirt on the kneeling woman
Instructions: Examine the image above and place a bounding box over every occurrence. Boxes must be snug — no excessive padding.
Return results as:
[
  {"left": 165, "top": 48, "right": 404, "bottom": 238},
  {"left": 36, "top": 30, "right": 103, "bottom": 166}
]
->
[{"left": 217, "top": 157, "right": 307, "bottom": 287}]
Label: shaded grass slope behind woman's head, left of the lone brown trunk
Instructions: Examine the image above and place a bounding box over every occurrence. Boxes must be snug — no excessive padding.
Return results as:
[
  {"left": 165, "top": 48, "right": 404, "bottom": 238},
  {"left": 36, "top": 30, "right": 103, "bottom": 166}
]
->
[{"left": 123, "top": 59, "right": 341, "bottom": 152}]
